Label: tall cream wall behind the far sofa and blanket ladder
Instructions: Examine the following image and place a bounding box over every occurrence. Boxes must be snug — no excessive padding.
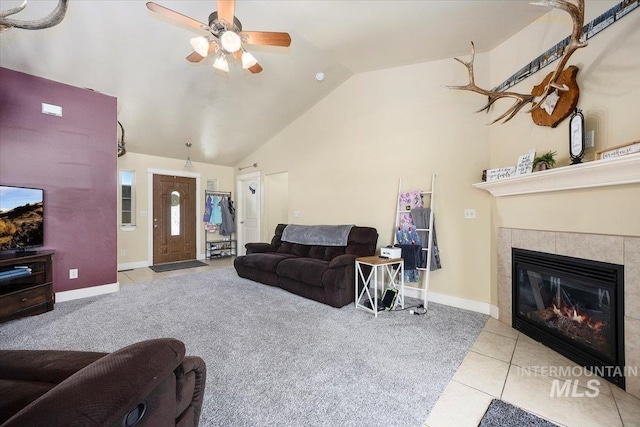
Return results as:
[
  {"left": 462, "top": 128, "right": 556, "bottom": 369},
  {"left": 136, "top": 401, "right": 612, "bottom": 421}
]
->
[{"left": 239, "top": 55, "right": 490, "bottom": 303}]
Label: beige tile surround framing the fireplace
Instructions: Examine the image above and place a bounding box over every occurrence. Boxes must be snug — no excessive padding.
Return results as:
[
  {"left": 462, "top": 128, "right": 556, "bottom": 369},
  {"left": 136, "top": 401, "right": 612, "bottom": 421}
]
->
[{"left": 497, "top": 228, "right": 640, "bottom": 398}]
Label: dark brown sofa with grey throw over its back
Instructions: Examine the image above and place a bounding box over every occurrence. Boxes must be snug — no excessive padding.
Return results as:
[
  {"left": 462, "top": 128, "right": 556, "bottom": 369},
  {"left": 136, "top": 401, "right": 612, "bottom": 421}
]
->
[{"left": 234, "top": 224, "right": 378, "bottom": 307}]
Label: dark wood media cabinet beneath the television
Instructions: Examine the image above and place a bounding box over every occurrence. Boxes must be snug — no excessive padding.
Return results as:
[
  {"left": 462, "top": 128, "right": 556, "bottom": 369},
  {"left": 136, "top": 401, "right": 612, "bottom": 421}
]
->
[{"left": 0, "top": 251, "right": 55, "bottom": 322}]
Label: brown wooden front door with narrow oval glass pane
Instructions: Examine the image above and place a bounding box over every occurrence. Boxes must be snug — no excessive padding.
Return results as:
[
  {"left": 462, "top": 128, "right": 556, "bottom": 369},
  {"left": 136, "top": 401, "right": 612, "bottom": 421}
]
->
[{"left": 153, "top": 175, "right": 196, "bottom": 265}]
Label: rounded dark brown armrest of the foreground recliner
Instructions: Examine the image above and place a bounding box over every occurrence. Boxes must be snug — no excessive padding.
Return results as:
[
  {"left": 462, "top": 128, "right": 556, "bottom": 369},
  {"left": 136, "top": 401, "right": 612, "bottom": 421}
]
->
[{"left": 3, "top": 338, "right": 190, "bottom": 427}]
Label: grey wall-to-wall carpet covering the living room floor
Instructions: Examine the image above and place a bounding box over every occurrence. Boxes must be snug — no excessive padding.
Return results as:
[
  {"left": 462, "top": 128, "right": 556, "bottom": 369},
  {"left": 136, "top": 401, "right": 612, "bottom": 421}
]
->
[{"left": 0, "top": 268, "right": 487, "bottom": 427}]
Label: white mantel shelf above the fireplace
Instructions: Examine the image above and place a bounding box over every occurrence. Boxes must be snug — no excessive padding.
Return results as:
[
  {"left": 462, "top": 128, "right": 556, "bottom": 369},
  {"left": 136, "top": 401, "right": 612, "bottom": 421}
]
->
[{"left": 473, "top": 153, "right": 640, "bottom": 197}]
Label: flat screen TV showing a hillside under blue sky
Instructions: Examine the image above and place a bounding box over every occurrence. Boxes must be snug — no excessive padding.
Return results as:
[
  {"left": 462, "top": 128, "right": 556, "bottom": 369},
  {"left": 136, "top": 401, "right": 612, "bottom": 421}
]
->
[{"left": 0, "top": 185, "right": 44, "bottom": 252}]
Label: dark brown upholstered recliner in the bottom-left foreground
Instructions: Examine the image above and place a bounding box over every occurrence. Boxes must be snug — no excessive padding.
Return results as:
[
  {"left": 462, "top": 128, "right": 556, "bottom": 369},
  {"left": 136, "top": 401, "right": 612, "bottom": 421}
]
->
[{"left": 0, "top": 338, "right": 206, "bottom": 427}]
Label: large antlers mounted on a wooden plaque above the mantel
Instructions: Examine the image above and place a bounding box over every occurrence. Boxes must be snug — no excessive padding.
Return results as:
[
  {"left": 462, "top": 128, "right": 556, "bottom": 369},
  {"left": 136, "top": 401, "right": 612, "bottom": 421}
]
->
[{"left": 445, "top": 0, "right": 587, "bottom": 127}]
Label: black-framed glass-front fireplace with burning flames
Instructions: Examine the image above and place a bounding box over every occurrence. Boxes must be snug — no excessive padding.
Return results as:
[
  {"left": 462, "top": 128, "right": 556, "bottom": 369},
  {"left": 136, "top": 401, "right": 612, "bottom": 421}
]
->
[{"left": 512, "top": 248, "right": 625, "bottom": 389}]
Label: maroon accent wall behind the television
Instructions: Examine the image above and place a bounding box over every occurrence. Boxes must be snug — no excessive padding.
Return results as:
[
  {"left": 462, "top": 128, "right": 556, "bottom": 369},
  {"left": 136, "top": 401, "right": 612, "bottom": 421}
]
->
[{"left": 0, "top": 68, "right": 118, "bottom": 292}]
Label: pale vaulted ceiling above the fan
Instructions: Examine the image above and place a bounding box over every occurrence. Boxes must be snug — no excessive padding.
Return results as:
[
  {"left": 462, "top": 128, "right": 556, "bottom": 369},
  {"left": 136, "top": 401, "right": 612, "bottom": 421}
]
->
[{"left": 0, "top": 0, "right": 549, "bottom": 166}]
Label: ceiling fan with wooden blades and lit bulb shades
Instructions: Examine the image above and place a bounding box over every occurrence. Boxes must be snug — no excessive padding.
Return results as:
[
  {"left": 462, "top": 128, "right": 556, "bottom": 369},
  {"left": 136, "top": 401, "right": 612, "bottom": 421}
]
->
[{"left": 147, "top": 0, "right": 291, "bottom": 74}]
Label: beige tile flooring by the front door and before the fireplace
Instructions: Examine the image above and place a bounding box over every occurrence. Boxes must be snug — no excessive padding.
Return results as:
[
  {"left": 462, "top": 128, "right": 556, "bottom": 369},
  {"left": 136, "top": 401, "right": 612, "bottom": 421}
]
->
[{"left": 118, "top": 258, "right": 640, "bottom": 427}]
